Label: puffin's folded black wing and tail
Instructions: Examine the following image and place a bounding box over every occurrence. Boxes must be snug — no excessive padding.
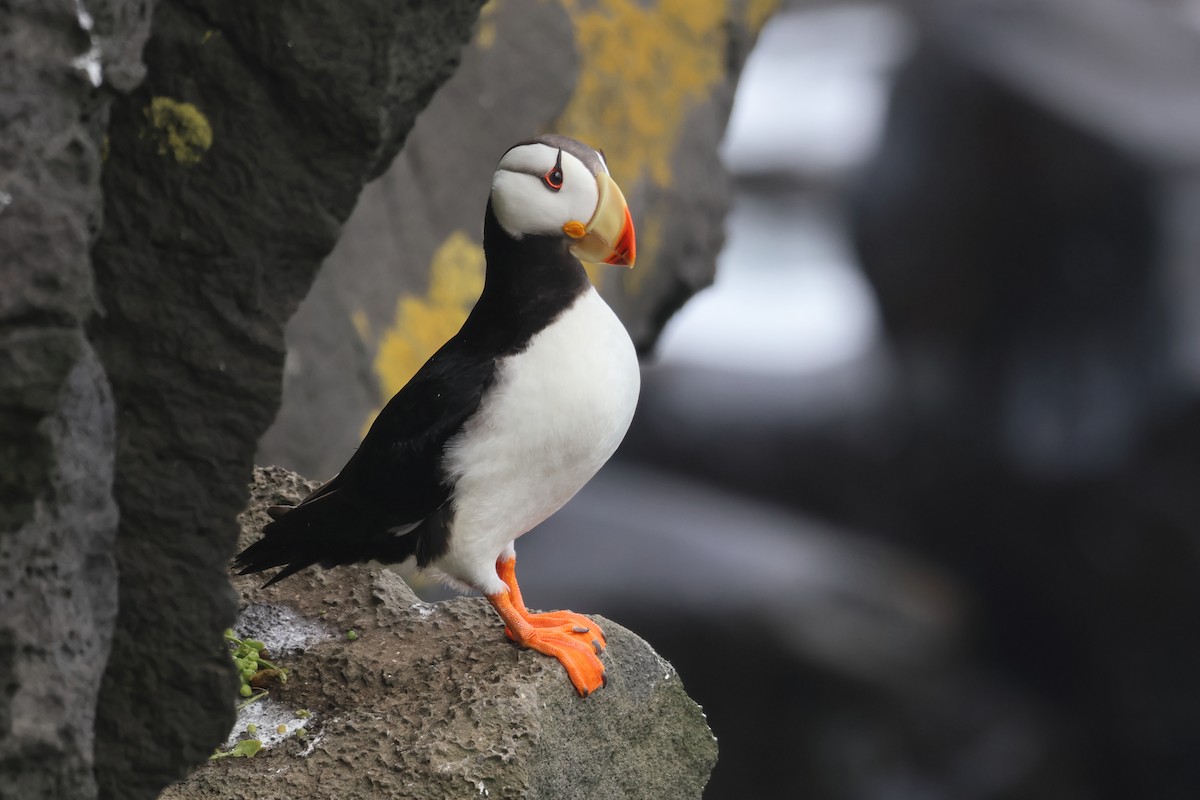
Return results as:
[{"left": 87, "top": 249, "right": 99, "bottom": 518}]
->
[{"left": 234, "top": 339, "right": 496, "bottom": 585}]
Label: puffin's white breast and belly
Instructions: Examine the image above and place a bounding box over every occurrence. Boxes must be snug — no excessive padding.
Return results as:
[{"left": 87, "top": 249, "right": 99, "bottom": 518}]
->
[{"left": 434, "top": 288, "right": 641, "bottom": 591}]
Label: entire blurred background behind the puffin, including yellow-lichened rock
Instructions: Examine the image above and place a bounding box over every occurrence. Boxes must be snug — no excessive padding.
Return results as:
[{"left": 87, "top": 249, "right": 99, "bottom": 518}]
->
[{"left": 259, "top": 0, "right": 1200, "bottom": 800}]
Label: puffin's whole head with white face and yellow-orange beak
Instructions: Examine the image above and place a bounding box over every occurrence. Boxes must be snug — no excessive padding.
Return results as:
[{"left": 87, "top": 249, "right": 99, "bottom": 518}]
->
[{"left": 492, "top": 133, "right": 636, "bottom": 266}]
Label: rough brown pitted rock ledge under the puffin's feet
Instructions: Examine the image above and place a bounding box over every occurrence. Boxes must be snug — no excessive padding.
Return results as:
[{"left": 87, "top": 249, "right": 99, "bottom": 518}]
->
[{"left": 162, "top": 467, "right": 716, "bottom": 800}]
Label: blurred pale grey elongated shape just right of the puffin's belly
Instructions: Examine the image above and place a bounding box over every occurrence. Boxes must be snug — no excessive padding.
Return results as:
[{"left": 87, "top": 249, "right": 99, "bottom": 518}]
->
[{"left": 517, "top": 463, "right": 965, "bottom": 684}]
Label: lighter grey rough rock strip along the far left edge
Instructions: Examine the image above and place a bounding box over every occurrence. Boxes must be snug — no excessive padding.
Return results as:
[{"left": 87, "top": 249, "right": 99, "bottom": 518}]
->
[{"left": 0, "top": 0, "right": 148, "bottom": 800}]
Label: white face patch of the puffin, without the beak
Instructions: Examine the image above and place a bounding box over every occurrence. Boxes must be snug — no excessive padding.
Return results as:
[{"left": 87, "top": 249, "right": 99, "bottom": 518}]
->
[{"left": 492, "top": 143, "right": 600, "bottom": 239}]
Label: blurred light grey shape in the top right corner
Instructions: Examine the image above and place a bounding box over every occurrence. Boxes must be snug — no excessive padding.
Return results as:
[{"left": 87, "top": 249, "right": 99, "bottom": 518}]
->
[{"left": 914, "top": 0, "right": 1200, "bottom": 169}]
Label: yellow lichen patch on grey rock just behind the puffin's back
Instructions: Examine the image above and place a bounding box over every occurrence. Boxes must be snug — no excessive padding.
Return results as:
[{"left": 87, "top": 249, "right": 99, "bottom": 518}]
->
[{"left": 355, "top": 230, "right": 484, "bottom": 433}]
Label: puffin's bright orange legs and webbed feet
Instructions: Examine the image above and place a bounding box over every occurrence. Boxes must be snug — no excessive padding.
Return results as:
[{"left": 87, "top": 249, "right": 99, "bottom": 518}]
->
[{"left": 487, "top": 559, "right": 607, "bottom": 697}]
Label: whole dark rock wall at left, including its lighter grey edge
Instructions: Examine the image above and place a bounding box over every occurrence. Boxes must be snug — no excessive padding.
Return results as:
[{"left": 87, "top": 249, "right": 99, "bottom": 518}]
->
[{"left": 0, "top": 0, "right": 480, "bottom": 800}]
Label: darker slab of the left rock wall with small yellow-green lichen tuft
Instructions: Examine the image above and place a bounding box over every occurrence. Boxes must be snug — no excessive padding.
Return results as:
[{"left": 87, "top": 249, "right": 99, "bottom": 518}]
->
[{"left": 90, "top": 0, "right": 479, "bottom": 798}]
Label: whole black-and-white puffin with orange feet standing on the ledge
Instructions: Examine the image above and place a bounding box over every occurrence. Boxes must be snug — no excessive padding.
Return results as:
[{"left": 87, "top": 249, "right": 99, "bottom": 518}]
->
[{"left": 234, "top": 134, "right": 641, "bottom": 697}]
